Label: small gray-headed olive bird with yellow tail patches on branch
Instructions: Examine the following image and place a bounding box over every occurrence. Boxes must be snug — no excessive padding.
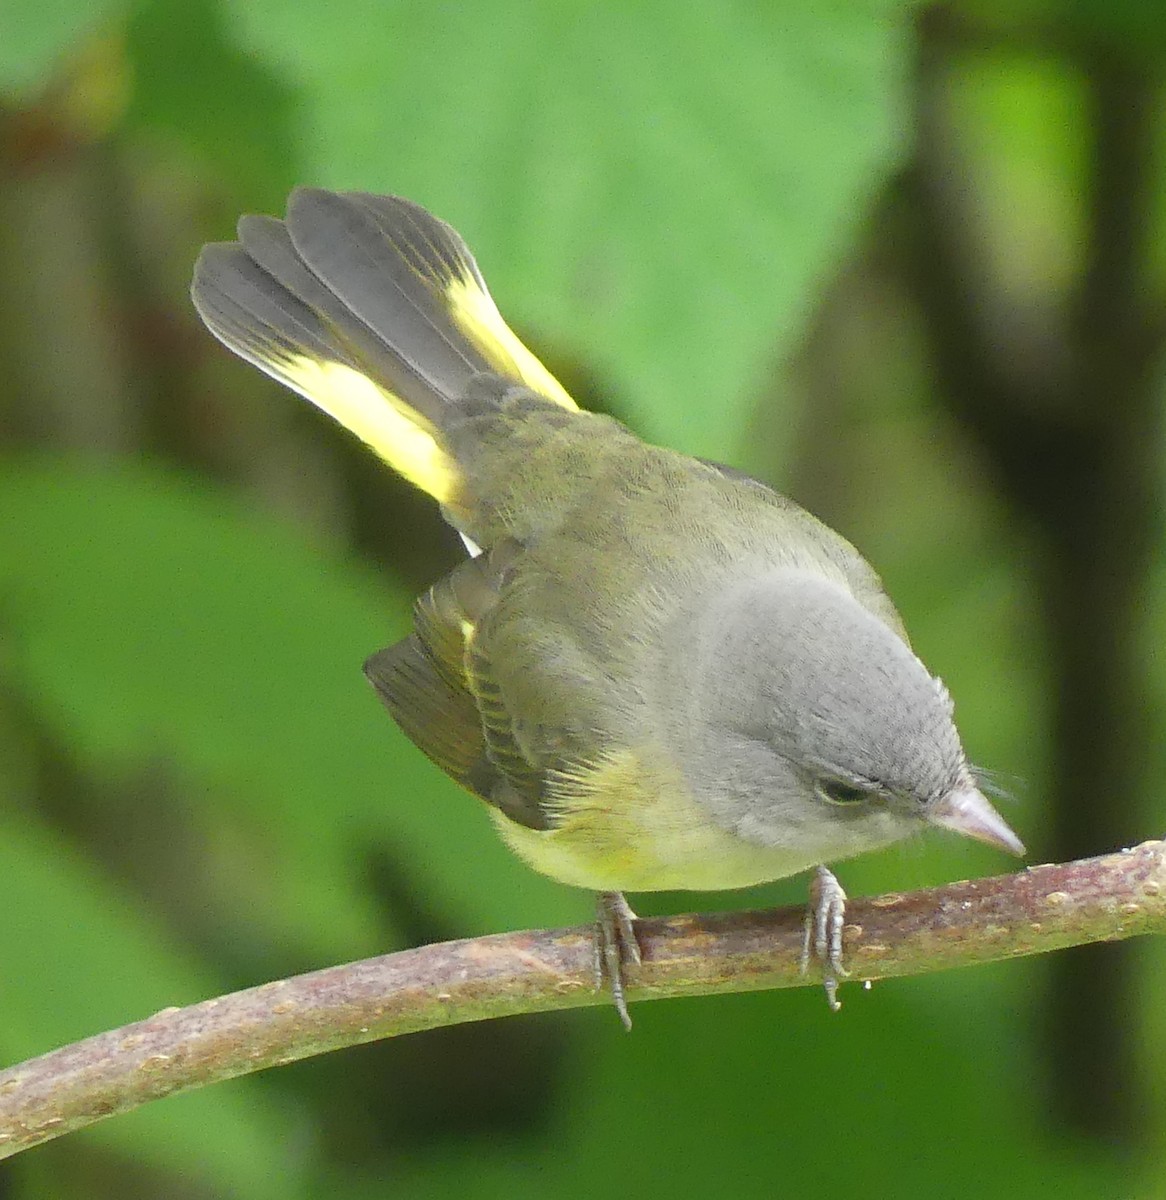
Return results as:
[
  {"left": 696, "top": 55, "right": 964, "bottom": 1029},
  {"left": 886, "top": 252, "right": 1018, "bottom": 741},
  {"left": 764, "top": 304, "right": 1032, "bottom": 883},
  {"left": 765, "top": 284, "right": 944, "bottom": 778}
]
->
[{"left": 192, "top": 187, "right": 1023, "bottom": 1028}]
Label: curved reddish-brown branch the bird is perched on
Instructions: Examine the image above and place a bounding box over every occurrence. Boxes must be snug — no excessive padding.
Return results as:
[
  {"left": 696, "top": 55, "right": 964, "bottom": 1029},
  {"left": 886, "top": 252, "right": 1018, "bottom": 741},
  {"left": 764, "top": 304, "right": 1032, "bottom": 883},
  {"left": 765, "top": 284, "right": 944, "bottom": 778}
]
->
[{"left": 0, "top": 841, "right": 1166, "bottom": 1158}]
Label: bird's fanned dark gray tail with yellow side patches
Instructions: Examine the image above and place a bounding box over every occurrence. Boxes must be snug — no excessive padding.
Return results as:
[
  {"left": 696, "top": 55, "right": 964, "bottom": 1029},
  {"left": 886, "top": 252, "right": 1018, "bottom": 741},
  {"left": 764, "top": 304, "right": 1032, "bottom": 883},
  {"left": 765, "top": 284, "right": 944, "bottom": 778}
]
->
[{"left": 191, "top": 188, "right": 577, "bottom": 503}]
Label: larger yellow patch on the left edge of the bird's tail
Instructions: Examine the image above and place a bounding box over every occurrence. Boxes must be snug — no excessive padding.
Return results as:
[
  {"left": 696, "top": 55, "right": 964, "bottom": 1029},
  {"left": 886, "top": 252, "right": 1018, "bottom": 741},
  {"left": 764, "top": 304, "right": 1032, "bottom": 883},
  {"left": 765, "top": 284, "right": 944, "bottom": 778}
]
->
[{"left": 278, "top": 355, "right": 458, "bottom": 504}]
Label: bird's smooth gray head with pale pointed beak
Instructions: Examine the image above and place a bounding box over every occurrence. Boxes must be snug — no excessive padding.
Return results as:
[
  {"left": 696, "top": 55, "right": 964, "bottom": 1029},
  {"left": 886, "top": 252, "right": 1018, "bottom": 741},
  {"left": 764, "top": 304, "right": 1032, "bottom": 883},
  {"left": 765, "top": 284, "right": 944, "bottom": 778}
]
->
[{"left": 676, "top": 571, "right": 1023, "bottom": 865}]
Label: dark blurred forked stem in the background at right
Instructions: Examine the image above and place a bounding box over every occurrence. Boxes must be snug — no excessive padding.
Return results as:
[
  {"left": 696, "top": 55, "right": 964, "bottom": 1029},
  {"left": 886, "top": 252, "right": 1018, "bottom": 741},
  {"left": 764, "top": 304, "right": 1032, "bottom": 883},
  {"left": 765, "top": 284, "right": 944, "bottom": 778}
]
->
[{"left": 901, "top": 8, "right": 1161, "bottom": 1144}]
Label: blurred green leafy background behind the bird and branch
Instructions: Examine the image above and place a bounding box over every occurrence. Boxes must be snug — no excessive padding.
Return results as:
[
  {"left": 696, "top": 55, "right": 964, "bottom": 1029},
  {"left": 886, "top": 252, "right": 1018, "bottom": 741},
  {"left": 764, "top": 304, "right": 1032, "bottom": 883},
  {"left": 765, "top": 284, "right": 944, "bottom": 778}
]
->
[{"left": 0, "top": 0, "right": 1166, "bottom": 1200}]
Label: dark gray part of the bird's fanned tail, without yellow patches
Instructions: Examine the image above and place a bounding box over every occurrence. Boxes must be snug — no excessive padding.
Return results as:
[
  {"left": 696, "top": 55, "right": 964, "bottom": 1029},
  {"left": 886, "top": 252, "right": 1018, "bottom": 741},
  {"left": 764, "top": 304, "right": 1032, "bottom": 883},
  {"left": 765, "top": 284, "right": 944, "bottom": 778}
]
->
[{"left": 191, "top": 188, "right": 495, "bottom": 430}]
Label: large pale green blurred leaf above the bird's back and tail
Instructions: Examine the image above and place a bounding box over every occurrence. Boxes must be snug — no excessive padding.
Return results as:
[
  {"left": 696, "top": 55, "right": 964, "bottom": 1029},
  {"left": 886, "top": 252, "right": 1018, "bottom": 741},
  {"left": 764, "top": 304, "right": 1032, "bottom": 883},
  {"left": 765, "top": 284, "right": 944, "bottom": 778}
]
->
[{"left": 207, "top": 0, "right": 909, "bottom": 458}]
